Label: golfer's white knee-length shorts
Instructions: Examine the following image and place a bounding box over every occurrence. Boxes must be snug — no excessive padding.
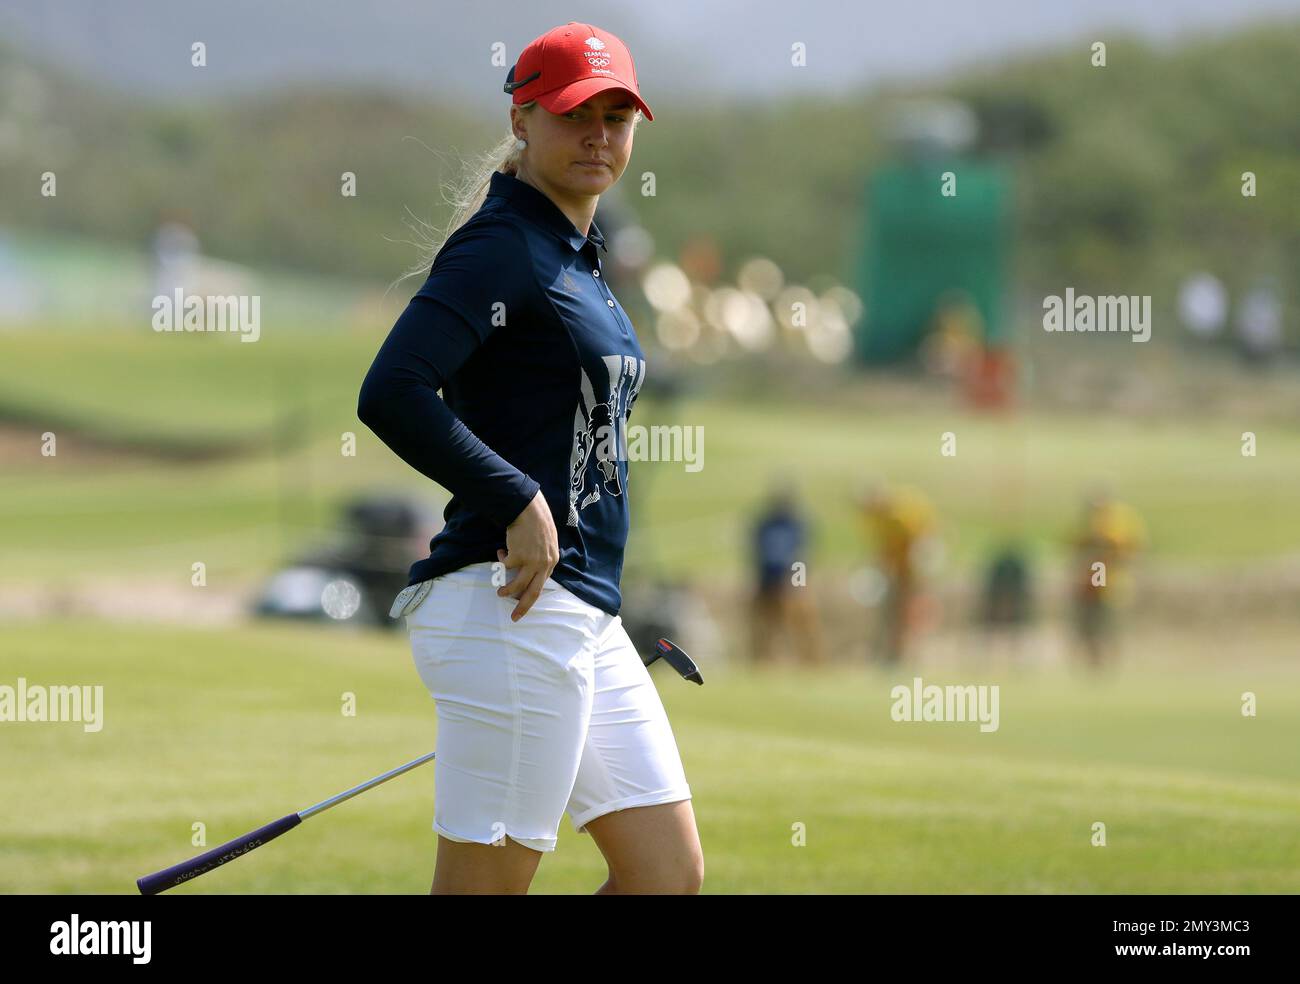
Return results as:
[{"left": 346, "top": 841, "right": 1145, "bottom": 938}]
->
[{"left": 407, "top": 562, "right": 690, "bottom": 851}]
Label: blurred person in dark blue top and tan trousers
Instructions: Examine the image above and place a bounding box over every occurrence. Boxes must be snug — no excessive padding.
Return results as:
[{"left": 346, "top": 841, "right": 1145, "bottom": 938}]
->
[{"left": 750, "top": 481, "right": 826, "bottom": 666}]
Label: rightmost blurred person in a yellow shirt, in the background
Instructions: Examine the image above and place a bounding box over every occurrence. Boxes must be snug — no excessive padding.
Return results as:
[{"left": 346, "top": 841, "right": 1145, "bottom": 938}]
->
[{"left": 1070, "top": 489, "right": 1147, "bottom": 669}]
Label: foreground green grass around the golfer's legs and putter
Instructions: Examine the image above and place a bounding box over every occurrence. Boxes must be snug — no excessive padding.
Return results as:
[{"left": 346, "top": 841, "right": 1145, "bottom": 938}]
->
[{"left": 0, "top": 621, "right": 1300, "bottom": 894}]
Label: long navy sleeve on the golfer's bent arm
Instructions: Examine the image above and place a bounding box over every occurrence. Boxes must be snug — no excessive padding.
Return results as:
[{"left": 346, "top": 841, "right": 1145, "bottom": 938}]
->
[{"left": 356, "top": 227, "right": 541, "bottom": 528}]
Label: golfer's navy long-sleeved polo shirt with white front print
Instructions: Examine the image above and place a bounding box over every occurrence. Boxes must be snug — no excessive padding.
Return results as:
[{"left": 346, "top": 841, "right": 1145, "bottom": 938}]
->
[{"left": 356, "top": 172, "right": 646, "bottom": 615}]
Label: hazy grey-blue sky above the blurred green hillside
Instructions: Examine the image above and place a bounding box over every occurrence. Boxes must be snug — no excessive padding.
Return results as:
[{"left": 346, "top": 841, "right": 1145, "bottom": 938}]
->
[{"left": 0, "top": 0, "right": 1300, "bottom": 113}]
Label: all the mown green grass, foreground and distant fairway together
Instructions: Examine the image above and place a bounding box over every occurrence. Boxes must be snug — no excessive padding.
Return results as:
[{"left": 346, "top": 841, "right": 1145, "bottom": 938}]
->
[{"left": 0, "top": 322, "right": 1300, "bottom": 893}]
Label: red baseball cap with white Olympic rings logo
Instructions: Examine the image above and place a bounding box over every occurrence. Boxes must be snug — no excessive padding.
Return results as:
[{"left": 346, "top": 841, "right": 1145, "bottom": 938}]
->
[{"left": 504, "top": 21, "right": 654, "bottom": 120}]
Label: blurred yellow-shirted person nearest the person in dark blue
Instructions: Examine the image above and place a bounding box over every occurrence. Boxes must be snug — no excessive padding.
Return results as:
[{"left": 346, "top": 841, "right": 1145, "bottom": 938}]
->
[{"left": 859, "top": 485, "right": 936, "bottom": 666}]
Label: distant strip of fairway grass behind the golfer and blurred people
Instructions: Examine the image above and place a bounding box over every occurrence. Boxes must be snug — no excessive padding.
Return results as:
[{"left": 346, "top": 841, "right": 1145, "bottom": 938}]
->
[{"left": 0, "top": 322, "right": 1300, "bottom": 580}]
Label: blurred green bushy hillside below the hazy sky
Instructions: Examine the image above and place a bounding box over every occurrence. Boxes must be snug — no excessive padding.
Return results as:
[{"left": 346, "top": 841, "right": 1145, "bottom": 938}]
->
[{"left": 0, "top": 21, "right": 1300, "bottom": 306}]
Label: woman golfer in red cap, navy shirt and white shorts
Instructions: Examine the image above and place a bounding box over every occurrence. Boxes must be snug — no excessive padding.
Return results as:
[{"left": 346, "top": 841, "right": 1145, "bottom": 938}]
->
[{"left": 358, "top": 22, "right": 703, "bottom": 894}]
